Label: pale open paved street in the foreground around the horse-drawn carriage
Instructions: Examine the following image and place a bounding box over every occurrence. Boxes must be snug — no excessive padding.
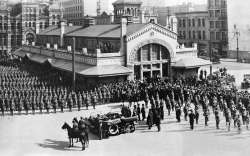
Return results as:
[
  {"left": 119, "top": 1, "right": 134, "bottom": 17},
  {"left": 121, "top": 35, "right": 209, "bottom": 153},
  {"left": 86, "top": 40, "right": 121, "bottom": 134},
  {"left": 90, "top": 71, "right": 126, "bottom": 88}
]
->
[{"left": 0, "top": 104, "right": 250, "bottom": 156}]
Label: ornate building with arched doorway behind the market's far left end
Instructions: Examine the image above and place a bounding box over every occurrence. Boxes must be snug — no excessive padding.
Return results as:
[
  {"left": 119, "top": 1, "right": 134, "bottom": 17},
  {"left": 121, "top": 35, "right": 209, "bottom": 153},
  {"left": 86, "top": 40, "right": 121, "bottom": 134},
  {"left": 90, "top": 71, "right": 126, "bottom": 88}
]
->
[{"left": 11, "top": 1, "right": 49, "bottom": 46}]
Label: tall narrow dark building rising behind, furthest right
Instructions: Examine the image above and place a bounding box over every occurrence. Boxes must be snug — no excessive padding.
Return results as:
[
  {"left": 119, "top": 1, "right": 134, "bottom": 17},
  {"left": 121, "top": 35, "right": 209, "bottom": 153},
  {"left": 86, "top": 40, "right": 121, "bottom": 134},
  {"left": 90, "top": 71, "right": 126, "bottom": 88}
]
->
[{"left": 208, "top": 0, "right": 228, "bottom": 57}]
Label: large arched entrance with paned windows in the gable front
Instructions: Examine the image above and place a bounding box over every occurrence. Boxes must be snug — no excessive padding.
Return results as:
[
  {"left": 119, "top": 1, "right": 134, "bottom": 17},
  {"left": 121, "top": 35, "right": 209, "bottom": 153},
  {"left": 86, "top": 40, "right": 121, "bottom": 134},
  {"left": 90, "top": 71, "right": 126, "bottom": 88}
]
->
[{"left": 131, "top": 43, "right": 171, "bottom": 80}]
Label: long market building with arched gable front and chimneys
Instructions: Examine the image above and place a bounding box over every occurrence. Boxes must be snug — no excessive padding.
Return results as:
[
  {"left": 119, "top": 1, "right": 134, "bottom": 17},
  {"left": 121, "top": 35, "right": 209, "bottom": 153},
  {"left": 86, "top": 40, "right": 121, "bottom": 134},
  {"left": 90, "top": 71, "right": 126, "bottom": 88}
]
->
[{"left": 12, "top": 0, "right": 210, "bottom": 83}]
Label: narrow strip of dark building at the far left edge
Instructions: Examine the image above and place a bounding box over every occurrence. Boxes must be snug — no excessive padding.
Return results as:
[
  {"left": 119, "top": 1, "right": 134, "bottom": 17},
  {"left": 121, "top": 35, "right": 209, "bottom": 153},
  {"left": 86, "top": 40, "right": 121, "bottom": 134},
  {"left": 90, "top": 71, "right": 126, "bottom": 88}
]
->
[{"left": 0, "top": 0, "right": 11, "bottom": 57}]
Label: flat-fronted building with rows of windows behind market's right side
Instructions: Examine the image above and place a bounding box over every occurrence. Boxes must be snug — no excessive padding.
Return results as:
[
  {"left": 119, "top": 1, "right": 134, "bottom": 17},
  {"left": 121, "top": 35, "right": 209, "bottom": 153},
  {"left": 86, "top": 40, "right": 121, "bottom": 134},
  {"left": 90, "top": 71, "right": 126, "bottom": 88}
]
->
[{"left": 176, "top": 11, "right": 210, "bottom": 55}]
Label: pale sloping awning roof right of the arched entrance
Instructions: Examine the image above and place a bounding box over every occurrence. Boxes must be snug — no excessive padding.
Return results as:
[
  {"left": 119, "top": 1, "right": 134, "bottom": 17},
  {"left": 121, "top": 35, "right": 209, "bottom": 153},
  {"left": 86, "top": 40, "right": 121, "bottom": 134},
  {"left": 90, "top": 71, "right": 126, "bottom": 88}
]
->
[{"left": 172, "top": 57, "right": 212, "bottom": 68}]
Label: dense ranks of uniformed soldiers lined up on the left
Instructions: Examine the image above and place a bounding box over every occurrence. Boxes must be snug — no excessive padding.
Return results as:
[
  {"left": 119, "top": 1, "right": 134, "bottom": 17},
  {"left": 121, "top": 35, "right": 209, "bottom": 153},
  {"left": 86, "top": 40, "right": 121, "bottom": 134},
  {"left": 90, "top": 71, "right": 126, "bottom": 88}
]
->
[{"left": 0, "top": 59, "right": 110, "bottom": 115}]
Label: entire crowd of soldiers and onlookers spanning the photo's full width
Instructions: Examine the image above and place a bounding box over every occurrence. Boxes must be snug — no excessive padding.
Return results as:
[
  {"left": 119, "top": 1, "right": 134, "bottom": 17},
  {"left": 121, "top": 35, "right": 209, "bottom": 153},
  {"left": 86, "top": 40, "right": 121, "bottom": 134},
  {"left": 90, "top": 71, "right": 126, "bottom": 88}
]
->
[{"left": 0, "top": 59, "right": 250, "bottom": 131}]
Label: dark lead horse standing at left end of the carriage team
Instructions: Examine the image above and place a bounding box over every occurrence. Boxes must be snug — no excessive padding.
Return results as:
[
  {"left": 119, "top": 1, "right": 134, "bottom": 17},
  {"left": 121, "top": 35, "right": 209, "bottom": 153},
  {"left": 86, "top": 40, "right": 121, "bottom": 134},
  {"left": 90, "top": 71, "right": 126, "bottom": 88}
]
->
[{"left": 62, "top": 122, "right": 89, "bottom": 150}]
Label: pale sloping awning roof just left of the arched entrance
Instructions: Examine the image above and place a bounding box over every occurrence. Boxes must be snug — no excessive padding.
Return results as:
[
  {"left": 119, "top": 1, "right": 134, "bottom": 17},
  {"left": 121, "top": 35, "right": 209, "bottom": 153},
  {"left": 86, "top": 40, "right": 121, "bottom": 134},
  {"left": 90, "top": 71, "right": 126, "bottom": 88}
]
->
[{"left": 80, "top": 65, "right": 132, "bottom": 77}]
